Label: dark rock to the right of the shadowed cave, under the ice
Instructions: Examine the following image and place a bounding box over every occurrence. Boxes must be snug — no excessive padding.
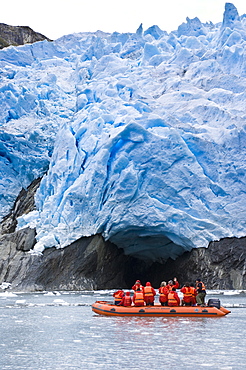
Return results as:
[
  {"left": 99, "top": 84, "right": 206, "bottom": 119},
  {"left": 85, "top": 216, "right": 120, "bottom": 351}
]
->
[{"left": 148, "top": 237, "right": 246, "bottom": 289}]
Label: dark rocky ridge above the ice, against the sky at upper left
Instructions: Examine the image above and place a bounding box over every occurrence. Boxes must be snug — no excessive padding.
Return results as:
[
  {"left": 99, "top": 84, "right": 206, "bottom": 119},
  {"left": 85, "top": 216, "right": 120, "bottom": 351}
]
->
[{"left": 0, "top": 23, "right": 50, "bottom": 49}]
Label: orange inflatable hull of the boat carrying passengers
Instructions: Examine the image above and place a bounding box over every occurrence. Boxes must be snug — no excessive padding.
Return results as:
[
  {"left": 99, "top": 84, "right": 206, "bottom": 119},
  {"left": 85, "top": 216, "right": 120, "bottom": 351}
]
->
[{"left": 92, "top": 301, "right": 231, "bottom": 317}]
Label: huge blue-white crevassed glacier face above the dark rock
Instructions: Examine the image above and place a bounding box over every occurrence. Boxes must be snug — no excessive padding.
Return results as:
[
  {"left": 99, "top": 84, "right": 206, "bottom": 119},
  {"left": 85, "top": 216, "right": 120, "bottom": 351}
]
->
[{"left": 0, "top": 3, "right": 246, "bottom": 261}]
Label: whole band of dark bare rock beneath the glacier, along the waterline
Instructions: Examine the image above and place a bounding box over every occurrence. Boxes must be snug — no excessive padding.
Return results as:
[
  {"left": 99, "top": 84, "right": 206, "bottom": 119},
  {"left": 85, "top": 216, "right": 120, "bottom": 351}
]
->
[{"left": 0, "top": 179, "right": 246, "bottom": 291}]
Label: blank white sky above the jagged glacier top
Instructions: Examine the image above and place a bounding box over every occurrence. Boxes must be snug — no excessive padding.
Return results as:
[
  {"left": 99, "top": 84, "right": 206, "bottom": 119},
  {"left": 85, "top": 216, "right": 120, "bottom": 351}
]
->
[{"left": 0, "top": 0, "right": 246, "bottom": 39}]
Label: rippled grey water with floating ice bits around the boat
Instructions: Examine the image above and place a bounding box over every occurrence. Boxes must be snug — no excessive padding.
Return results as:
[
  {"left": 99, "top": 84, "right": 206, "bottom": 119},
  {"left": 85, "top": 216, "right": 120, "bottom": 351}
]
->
[{"left": 0, "top": 291, "right": 246, "bottom": 370}]
